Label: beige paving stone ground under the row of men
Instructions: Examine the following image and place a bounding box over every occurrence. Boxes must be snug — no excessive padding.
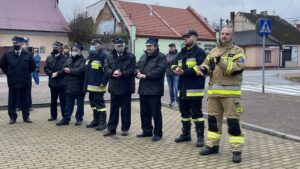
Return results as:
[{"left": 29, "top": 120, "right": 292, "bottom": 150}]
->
[{"left": 0, "top": 102, "right": 300, "bottom": 169}]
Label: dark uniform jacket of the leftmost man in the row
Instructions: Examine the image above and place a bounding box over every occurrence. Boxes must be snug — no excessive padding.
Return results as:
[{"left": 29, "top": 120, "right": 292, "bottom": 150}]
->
[{"left": 0, "top": 49, "right": 35, "bottom": 89}]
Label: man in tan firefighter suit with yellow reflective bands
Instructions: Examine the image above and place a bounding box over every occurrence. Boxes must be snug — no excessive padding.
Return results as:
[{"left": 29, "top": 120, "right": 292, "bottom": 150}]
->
[{"left": 199, "top": 26, "right": 246, "bottom": 163}]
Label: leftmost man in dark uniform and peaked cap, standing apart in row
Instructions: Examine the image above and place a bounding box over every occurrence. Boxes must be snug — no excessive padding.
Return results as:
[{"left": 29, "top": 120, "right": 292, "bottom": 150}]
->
[{"left": 0, "top": 36, "right": 35, "bottom": 124}]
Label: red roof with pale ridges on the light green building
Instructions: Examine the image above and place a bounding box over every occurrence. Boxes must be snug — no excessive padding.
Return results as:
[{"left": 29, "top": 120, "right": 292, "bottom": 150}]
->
[{"left": 114, "top": 1, "right": 215, "bottom": 40}]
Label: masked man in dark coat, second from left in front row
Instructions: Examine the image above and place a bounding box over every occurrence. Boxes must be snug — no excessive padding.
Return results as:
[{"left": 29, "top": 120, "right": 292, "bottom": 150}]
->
[{"left": 44, "top": 41, "right": 68, "bottom": 121}]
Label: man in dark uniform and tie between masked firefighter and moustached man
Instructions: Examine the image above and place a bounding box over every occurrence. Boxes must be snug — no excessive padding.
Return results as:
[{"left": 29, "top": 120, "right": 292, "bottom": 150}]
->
[{"left": 104, "top": 38, "right": 136, "bottom": 136}]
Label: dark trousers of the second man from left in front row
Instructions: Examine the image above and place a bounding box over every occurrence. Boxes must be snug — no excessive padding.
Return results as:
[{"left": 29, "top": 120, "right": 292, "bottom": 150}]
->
[{"left": 50, "top": 87, "right": 66, "bottom": 119}]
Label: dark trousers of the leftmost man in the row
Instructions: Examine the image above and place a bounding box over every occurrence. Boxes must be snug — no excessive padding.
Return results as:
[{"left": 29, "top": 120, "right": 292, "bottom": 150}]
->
[{"left": 8, "top": 87, "right": 30, "bottom": 120}]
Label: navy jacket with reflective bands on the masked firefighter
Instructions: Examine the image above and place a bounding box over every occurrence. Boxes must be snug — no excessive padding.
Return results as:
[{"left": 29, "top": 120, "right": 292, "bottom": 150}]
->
[{"left": 84, "top": 49, "right": 108, "bottom": 93}]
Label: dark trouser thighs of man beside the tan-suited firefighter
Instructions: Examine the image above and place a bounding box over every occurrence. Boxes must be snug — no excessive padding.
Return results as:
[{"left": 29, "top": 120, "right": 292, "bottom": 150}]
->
[{"left": 179, "top": 98, "right": 203, "bottom": 119}]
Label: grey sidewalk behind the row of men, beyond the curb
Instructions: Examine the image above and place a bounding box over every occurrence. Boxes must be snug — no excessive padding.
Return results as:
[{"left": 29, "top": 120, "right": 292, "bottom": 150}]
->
[{"left": 0, "top": 77, "right": 300, "bottom": 136}]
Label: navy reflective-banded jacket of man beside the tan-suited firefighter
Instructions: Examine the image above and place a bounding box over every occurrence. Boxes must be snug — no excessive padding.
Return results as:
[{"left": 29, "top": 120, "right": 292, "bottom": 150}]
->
[{"left": 172, "top": 45, "right": 206, "bottom": 99}]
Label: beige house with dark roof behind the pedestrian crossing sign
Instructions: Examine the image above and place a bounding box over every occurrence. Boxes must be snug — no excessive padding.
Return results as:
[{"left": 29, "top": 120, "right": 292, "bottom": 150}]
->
[{"left": 231, "top": 10, "right": 300, "bottom": 69}]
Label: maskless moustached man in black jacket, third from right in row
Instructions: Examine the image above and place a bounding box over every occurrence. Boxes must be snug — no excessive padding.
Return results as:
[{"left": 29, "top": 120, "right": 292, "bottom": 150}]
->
[{"left": 136, "top": 38, "right": 168, "bottom": 141}]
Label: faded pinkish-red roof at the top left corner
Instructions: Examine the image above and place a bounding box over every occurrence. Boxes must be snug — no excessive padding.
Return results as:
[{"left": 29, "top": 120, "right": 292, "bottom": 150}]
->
[{"left": 0, "top": 0, "right": 68, "bottom": 32}]
